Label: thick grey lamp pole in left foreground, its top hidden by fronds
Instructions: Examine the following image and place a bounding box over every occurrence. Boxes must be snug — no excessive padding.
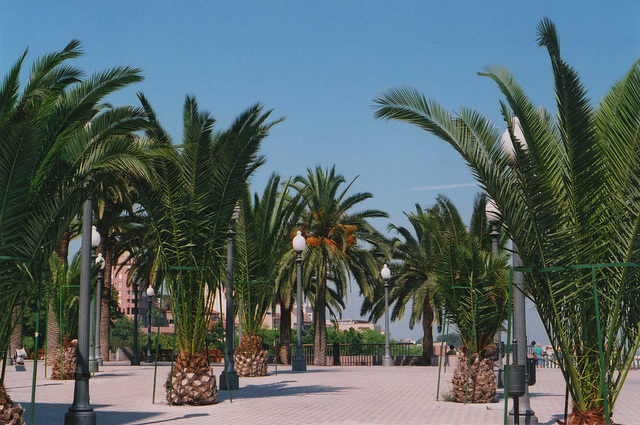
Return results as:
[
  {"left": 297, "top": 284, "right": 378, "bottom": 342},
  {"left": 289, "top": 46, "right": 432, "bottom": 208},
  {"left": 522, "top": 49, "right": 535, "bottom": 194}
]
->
[{"left": 64, "top": 197, "right": 100, "bottom": 425}]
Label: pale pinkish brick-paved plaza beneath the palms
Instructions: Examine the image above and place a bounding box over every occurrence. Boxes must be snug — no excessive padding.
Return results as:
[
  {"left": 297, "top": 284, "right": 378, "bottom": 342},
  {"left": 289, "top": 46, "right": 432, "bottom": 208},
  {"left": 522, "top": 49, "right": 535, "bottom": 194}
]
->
[{"left": 5, "top": 362, "right": 640, "bottom": 425}]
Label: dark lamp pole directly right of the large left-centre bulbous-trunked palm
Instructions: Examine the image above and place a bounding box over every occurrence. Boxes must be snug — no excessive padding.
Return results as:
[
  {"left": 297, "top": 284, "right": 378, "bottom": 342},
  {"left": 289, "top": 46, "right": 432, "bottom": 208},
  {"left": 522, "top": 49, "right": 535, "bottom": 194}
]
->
[{"left": 220, "top": 205, "right": 240, "bottom": 391}]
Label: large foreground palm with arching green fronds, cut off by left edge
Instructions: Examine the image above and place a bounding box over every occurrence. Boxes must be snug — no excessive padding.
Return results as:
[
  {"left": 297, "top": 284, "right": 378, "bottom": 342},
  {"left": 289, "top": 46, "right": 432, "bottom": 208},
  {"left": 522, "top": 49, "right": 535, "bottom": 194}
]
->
[{"left": 0, "top": 40, "right": 144, "bottom": 420}]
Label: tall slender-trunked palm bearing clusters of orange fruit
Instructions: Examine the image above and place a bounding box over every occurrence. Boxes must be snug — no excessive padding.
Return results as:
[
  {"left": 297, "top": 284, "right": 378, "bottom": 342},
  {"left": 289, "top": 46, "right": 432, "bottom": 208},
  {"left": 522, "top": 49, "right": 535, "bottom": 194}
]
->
[{"left": 295, "top": 166, "right": 387, "bottom": 366}]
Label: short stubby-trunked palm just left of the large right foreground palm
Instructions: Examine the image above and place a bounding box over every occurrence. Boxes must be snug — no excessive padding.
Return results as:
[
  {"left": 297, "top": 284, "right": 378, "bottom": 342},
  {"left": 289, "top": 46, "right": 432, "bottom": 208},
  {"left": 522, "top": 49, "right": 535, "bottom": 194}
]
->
[{"left": 434, "top": 195, "right": 509, "bottom": 403}]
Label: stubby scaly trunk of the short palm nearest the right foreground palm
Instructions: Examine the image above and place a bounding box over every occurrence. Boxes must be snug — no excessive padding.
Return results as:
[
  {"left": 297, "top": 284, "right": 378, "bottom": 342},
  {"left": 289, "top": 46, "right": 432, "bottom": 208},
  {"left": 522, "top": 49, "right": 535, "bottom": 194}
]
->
[{"left": 452, "top": 349, "right": 497, "bottom": 403}]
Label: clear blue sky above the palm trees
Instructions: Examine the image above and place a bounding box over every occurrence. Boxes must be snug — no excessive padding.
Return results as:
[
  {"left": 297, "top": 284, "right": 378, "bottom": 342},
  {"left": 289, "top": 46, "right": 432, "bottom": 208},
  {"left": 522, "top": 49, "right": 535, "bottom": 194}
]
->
[{"left": 0, "top": 0, "right": 640, "bottom": 341}]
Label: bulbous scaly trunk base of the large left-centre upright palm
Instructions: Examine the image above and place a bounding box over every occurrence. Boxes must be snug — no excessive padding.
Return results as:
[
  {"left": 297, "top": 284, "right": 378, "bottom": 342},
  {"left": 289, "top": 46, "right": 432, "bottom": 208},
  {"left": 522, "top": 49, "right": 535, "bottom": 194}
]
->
[{"left": 165, "top": 352, "right": 218, "bottom": 406}]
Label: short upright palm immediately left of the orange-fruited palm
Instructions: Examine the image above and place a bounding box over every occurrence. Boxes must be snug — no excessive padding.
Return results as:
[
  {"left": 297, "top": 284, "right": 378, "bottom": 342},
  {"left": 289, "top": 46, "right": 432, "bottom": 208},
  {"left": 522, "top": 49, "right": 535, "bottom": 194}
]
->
[{"left": 234, "top": 174, "right": 304, "bottom": 376}]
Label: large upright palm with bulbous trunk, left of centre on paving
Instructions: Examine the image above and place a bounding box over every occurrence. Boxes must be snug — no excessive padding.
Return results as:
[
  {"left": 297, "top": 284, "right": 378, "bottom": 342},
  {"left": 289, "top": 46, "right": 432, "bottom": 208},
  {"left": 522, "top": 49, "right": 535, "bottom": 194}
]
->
[{"left": 137, "top": 95, "right": 275, "bottom": 404}]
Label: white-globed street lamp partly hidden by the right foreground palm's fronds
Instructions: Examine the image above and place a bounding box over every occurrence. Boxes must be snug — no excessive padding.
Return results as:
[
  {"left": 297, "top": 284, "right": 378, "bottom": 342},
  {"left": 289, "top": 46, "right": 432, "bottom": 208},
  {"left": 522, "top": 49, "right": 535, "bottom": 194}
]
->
[{"left": 500, "top": 117, "right": 538, "bottom": 425}]
